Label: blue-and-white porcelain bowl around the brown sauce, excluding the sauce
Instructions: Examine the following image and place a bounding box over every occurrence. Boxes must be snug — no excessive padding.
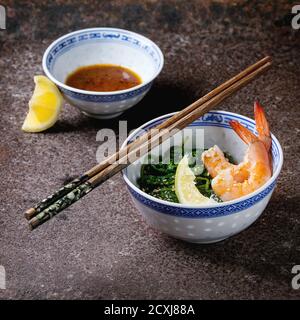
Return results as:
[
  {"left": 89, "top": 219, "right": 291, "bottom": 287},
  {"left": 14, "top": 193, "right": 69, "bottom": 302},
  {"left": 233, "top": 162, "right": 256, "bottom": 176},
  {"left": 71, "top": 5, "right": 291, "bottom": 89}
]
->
[{"left": 43, "top": 28, "right": 164, "bottom": 119}]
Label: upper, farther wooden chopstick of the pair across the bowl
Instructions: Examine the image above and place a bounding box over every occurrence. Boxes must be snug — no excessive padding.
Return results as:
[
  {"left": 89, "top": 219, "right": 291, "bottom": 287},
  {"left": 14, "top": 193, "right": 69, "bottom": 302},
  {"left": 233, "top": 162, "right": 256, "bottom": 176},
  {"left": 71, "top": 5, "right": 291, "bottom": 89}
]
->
[{"left": 25, "top": 56, "right": 271, "bottom": 220}]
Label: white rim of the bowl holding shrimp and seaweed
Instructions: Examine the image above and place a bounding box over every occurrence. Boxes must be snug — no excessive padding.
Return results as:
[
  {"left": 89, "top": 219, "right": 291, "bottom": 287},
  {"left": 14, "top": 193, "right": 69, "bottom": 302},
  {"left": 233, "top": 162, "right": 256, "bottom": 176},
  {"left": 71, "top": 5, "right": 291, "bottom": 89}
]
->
[{"left": 121, "top": 110, "right": 283, "bottom": 209}]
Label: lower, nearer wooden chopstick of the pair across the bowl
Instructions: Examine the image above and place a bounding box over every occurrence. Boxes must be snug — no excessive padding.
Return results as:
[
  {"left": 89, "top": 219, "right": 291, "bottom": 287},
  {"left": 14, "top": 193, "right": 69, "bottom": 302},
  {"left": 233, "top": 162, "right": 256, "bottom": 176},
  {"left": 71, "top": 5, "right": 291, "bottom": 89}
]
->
[{"left": 29, "top": 59, "right": 271, "bottom": 229}]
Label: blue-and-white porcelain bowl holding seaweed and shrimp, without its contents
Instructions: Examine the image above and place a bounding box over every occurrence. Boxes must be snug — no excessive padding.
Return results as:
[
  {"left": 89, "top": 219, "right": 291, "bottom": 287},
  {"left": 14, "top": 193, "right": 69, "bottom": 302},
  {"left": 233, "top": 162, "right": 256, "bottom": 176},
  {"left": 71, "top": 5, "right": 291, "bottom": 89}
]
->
[{"left": 123, "top": 111, "right": 283, "bottom": 243}]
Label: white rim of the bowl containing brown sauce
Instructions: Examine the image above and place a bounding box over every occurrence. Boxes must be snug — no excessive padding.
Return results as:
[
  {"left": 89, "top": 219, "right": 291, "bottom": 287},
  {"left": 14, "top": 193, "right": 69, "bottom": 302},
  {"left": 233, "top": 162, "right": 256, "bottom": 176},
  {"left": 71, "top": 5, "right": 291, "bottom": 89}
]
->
[{"left": 42, "top": 27, "right": 164, "bottom": 96}]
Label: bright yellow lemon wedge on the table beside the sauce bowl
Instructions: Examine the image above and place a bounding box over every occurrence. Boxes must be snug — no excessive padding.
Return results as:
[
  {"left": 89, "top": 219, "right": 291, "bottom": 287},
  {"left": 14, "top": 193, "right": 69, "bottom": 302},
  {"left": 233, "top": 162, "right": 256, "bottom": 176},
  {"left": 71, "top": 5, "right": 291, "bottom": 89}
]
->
[{"left": 22, "top": 76, "right": 63, "bottom": 132}]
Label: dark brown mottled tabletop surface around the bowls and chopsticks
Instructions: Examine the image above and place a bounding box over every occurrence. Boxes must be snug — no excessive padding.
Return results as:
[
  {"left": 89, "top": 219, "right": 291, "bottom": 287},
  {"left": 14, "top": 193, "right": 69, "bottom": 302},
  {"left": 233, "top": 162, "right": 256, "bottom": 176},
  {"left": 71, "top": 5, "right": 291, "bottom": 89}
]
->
[{"left": 0, "top": 0, "right": 300, "bottom": 299}]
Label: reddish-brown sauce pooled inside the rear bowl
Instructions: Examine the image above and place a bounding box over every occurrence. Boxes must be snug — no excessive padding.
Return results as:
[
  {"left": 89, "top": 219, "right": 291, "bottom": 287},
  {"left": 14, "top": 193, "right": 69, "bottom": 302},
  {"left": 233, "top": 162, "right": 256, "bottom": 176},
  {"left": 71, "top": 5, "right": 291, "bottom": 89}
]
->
[{"left": 66, "top": 64, "right": 142, "bottom": 92}]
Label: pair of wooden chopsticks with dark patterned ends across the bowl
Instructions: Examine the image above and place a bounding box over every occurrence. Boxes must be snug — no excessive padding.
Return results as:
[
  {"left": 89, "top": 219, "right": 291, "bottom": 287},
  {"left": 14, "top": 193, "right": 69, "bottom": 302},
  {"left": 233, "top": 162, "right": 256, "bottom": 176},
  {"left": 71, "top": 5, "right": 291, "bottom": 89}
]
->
[{"left": 25, "top": 56, "right": 271, "bottom": 230}]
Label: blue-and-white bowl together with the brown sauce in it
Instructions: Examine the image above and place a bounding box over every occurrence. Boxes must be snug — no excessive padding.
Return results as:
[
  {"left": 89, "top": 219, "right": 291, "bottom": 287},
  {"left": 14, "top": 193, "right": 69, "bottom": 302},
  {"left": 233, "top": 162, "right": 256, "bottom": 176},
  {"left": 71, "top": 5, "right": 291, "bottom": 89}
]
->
[{"left": 43, "top": 28, "right": 164, "bottom": 119}]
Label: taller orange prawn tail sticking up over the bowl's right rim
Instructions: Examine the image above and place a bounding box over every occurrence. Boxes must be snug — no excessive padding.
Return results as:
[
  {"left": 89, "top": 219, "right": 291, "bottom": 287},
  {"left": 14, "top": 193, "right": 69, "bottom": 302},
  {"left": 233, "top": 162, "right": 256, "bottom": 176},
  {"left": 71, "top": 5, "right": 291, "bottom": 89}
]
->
[{"left": 254, "top": 101, "right": 272, "bottom": 151}]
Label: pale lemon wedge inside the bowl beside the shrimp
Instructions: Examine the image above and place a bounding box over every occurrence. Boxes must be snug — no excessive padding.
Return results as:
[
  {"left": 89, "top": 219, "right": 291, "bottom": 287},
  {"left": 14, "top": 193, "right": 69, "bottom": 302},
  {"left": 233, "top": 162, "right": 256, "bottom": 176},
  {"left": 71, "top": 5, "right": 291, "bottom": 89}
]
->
[{"left": 175, "top": 156, "right": 216, "bottom": 204}]
